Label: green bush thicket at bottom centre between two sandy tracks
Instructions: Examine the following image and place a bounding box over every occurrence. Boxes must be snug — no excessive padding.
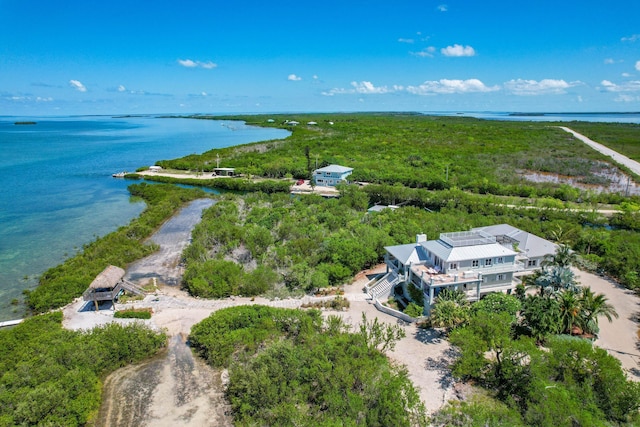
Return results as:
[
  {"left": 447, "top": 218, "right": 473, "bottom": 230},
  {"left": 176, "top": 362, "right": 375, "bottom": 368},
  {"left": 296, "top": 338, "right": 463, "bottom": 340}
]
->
[{"left": 190, "top": 306, "right": 426, "bottom": 427}]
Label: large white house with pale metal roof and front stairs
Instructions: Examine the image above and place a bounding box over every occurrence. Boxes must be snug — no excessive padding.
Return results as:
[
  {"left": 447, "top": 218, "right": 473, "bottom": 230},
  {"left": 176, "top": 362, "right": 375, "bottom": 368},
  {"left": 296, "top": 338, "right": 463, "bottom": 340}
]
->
[{"left": 369, "top": 224, "right": 556, "bottom": 314}]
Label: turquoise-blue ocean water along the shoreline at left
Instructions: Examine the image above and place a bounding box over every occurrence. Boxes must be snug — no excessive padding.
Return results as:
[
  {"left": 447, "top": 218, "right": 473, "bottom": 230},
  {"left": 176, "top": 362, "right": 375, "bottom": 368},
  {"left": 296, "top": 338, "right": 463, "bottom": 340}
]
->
[{"left": 0, "top": 117, "right": 289, "bottom": 321}]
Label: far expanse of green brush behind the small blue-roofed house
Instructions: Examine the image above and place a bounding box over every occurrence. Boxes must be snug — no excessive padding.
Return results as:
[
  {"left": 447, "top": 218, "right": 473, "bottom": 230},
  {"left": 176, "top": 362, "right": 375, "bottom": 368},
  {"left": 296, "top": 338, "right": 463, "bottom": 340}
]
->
[{"left": 158, "top": 113, "right": 638, "bottom": 203}]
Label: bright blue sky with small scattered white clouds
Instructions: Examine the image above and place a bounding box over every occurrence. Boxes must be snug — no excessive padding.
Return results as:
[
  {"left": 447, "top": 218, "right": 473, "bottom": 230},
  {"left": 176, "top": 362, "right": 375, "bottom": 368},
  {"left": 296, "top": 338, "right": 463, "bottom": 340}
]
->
[{"left": 0, "top": 0, "right": 640, "bottom": 115}]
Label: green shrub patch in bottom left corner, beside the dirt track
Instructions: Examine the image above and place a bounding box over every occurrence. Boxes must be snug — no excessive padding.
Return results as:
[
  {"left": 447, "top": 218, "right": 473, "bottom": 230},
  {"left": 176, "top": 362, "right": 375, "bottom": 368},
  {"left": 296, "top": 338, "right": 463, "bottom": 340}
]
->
[{"left": 0, "top": 311, "right": 166, "bottom": 426}]
